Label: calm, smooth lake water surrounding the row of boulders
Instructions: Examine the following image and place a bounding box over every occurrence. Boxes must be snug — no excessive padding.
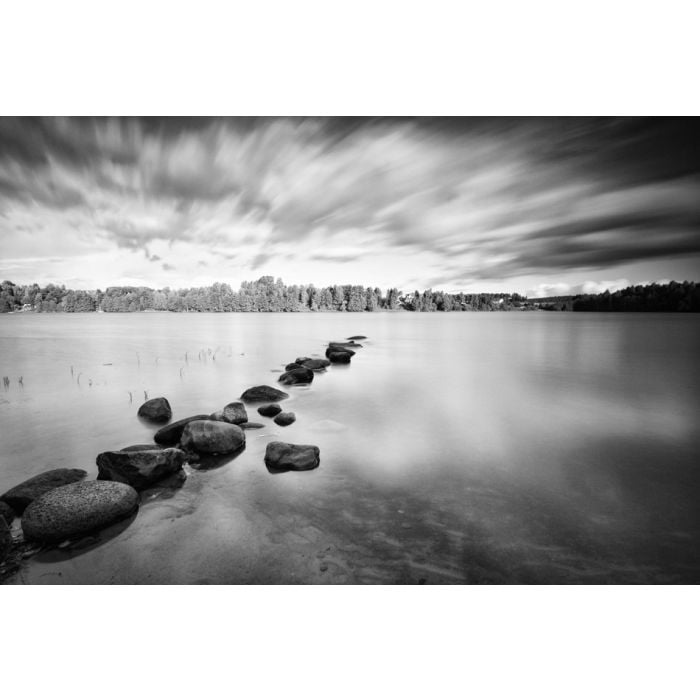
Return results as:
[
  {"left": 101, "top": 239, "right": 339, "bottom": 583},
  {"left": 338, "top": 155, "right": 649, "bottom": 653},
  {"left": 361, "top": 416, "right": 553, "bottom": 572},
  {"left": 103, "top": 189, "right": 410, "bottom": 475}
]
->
[{"left": 0, "top": 313, "right": 700, "bottom": 584}]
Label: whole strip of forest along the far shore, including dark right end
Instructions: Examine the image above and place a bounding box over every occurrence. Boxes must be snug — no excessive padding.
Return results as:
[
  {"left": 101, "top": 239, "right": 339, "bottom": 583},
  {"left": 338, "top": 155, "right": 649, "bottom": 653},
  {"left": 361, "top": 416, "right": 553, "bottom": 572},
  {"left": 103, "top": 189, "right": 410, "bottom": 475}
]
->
[{"left": 0, "top": 276, "right": 700, "bottom": 313}]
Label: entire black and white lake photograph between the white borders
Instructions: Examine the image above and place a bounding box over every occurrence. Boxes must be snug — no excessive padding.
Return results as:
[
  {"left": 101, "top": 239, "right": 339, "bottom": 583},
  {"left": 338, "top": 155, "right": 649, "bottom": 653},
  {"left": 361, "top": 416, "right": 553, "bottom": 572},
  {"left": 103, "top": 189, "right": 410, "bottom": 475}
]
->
[{"left": 0, "top": 117, "right": 700, "bottom": 585}]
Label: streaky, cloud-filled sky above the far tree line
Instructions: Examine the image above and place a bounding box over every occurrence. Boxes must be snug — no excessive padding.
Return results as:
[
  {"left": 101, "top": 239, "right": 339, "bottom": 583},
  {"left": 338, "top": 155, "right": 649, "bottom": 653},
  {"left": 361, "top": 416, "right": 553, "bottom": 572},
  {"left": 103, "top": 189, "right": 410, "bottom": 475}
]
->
[{"left": 0, "top": 117, "right": 700, "bottom": 297}]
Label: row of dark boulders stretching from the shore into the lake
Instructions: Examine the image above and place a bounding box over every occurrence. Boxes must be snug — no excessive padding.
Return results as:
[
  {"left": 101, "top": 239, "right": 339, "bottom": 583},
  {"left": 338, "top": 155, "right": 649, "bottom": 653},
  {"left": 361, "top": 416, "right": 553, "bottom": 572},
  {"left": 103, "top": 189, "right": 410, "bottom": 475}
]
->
[{"left": 0, "top": 336, "right": 366, "bottom": 574}]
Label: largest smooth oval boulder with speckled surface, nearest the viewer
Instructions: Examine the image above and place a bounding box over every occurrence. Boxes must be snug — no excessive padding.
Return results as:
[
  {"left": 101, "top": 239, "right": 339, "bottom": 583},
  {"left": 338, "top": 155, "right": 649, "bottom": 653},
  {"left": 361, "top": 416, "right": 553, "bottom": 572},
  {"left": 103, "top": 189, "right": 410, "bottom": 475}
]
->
[{"left": 22, "top": 481, "right": 139, "bottom": 542}]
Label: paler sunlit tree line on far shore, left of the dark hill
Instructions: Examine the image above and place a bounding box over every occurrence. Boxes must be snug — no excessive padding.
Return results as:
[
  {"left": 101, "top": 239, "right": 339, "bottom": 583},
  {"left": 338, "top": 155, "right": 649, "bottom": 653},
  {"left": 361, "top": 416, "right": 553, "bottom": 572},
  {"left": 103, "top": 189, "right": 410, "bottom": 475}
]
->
[{"left": 0, "top": 276, "right": 525, "bottom": 313}]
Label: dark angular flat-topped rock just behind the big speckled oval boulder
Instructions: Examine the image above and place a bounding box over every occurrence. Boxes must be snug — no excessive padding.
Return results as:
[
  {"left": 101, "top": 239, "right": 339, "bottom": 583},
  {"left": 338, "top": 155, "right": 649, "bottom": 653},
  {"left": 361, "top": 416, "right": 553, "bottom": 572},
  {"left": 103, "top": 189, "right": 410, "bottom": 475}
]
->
[{"left": 96, "top": 447, "right": 185, "bottom": 491}]
